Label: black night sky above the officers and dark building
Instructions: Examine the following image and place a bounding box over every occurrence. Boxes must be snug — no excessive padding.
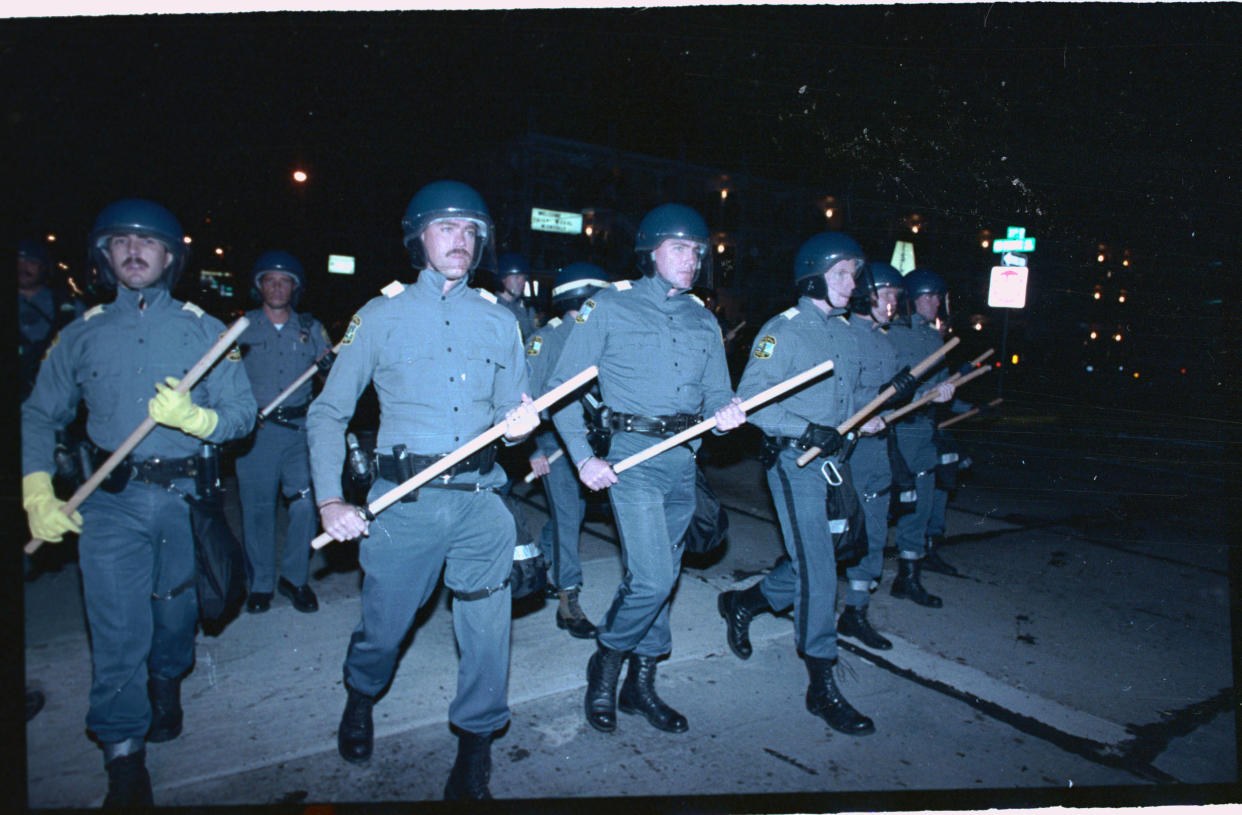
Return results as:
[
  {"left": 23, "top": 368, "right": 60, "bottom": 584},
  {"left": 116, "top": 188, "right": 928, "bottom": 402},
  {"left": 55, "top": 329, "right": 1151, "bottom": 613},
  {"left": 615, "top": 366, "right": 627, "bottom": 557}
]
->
[{"left": 0, "top": 4, "right": 1242, "bottom": 315}]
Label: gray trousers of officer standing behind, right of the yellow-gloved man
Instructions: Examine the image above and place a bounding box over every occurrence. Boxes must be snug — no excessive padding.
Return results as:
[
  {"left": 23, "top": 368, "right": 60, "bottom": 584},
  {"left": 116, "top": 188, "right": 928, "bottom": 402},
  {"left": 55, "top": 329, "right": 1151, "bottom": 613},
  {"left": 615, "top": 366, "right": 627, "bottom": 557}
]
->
[{"left": 236, "top": 420, "right": 319, "bottom": 594}]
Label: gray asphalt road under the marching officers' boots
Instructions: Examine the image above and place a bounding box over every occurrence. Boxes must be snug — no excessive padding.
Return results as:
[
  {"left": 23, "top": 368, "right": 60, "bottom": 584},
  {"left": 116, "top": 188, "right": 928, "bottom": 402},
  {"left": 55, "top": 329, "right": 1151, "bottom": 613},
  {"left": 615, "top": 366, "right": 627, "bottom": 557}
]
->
[{"left": 25, "top": 396, "right": 1242, "bottom": 811}]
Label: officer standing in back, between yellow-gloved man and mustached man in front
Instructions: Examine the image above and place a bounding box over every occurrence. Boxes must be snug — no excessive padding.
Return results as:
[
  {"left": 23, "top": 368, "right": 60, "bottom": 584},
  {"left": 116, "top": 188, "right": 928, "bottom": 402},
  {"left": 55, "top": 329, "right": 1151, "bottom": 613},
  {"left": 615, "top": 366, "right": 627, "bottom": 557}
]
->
[{"left": 236, "top": 251, "right": 332, "bottom": 614}]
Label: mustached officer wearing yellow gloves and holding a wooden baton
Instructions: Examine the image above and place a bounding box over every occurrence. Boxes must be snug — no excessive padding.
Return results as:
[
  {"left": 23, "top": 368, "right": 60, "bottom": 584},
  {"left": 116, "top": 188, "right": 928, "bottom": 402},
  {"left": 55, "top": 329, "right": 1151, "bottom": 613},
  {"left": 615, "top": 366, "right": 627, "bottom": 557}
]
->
[{"left": 22, "top": 199, "right": 257, "bottom": 808}]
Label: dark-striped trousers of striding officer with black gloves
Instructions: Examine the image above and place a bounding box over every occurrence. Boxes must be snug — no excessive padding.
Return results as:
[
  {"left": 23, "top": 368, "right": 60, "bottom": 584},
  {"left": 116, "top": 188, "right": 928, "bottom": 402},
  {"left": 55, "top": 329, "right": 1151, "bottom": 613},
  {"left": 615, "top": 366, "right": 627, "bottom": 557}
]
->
[{"left": 759, "top": 448, "right": 847, "bottom": 660}]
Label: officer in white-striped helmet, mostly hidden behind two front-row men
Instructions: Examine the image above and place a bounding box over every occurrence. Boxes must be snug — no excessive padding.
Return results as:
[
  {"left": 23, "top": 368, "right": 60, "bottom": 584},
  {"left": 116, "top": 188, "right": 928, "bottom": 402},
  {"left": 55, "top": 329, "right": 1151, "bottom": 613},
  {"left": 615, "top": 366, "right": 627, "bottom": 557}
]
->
[{"left": 527, "top": 262, "right": 609, "bottom": 639}]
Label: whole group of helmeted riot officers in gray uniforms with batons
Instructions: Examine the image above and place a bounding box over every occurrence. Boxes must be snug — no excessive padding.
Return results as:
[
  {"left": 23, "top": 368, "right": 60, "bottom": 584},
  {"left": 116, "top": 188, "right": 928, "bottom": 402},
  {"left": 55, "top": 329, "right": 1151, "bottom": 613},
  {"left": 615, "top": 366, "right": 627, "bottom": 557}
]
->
[{"left": 19, "top": 181, "right": 965, "bottom": 808}]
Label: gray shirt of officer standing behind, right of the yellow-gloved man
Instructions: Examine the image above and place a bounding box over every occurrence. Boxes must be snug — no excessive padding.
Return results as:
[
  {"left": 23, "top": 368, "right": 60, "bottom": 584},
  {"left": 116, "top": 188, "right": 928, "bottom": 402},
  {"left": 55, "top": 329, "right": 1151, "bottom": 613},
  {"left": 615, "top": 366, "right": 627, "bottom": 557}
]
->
[{"left": 237, "top": 308, "right": 332, "bottom": 408}]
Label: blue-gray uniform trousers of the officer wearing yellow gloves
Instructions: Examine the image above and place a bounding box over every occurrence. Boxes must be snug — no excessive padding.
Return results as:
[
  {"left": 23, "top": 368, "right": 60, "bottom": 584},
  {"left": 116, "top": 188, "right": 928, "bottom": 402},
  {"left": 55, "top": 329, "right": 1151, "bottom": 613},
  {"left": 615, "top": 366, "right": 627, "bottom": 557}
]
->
[{"left": 78, "top": 478, "right": 199, "bottom": 743}]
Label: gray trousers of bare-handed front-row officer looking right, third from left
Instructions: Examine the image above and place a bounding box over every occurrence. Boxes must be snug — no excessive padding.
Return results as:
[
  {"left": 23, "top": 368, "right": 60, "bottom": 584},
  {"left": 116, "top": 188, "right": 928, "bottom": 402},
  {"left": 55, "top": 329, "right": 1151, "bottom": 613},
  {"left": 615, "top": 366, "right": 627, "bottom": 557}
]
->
[{"left": 597, "top": 432, "right": 696, "bottom": 657}]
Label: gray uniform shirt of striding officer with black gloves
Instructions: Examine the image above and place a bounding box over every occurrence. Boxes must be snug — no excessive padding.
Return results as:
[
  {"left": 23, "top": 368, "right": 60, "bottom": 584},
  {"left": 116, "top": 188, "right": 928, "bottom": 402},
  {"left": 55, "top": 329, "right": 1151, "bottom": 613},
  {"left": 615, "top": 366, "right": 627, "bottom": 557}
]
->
[{"left": 738, "top": 297, "right": 861, "bottom": 439}]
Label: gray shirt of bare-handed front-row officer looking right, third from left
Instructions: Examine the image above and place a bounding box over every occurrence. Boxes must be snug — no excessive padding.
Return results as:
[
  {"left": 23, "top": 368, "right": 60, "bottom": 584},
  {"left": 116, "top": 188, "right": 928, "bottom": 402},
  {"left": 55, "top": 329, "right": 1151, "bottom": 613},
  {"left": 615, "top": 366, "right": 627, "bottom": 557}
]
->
[{"left": 548, "top": 275, "right": 733, "bottom": 463}]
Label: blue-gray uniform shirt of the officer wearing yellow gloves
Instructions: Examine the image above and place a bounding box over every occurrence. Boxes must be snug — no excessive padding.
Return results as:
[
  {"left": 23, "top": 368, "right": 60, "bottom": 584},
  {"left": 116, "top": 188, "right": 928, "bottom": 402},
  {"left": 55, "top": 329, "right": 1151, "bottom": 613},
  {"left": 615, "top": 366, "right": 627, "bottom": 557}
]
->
[{"left": 21, "top": 287, "right": 258, "bottom": 475}]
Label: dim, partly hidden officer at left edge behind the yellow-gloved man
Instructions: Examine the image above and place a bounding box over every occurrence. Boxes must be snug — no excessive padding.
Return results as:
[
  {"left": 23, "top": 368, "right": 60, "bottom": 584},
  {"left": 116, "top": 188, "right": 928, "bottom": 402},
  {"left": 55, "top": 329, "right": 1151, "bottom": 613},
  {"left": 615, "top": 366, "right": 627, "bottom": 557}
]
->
[{"left": 17, "top": 237, "right": 84, "bottom": 400}]
